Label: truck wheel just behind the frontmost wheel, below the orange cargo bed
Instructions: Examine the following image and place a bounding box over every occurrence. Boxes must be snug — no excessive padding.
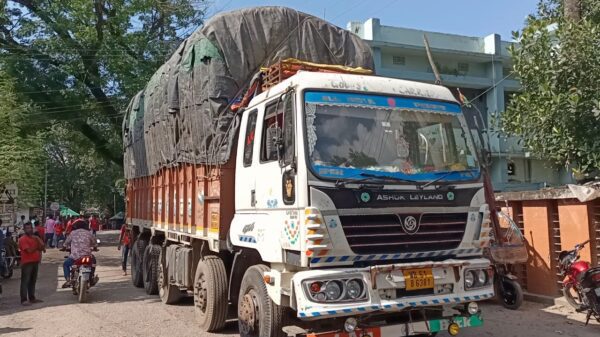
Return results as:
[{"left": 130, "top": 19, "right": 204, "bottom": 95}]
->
[{"left": 194, "top": 256, "right": 227, "bottom": 332}]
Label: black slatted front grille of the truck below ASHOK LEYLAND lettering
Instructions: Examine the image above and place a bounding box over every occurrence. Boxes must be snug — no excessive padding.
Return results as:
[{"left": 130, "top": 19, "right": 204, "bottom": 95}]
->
[{"left": 340, "top": 213, "right": 468, "bottom": 255}]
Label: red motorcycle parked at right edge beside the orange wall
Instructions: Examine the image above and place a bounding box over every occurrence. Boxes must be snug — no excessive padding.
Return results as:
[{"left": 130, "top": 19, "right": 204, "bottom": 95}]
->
[{"left": 558, "top": 240, "right": 600, "bottom": 325}]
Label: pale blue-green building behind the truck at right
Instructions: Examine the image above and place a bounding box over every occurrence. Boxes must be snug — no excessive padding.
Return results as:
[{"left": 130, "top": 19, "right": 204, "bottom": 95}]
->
[{"left": 347, "top": 18, "right": 572, "bottom": 191}]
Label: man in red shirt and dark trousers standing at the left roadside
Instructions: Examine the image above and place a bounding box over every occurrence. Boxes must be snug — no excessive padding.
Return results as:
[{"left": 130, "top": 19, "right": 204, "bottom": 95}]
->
[{"left": 19, "top": 222, "right": 46, "bottom": 305}]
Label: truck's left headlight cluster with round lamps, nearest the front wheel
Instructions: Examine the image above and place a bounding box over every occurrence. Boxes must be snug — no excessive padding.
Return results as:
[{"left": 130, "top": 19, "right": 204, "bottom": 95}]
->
[{"left": 302, "top": 277, "right": 367, "bottom": 303}]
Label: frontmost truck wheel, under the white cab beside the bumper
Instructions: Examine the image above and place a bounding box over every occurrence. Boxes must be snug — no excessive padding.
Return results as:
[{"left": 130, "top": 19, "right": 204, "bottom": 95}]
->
[{"left": 238, "top": 265, "right": 288, "bottom": 337}]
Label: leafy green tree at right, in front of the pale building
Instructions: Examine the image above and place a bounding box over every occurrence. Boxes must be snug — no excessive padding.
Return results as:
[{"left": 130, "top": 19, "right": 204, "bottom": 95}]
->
[{"left": 502, "top": 0, "right": 600, "bottom": 175}]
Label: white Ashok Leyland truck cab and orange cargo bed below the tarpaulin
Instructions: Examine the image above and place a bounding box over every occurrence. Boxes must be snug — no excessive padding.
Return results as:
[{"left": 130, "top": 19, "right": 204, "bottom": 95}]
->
[{"left": 126, "top": 7, "right": 494, "bottom": 337}]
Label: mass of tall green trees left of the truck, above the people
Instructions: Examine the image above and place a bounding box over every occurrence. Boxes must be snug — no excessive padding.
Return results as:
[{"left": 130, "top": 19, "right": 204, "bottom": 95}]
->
[{"left": 0, "top": 0, "right": 206, "bottom": 210}]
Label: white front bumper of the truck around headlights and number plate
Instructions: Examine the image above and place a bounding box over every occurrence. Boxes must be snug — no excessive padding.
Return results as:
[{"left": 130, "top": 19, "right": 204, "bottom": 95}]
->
[{"left": 292, "top": 259, "right": 494, "bottom": 320}]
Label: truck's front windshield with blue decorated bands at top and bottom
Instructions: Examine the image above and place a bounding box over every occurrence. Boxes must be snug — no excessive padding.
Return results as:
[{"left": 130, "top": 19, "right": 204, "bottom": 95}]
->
[{"left": 304, "top": 91, "right": 479, "bottom": 181}]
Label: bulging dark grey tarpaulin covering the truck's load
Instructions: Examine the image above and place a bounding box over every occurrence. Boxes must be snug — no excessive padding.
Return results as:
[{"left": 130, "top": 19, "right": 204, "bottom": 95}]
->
[{"left": 123, "top": 7, "right": 373, "bottom": 178}]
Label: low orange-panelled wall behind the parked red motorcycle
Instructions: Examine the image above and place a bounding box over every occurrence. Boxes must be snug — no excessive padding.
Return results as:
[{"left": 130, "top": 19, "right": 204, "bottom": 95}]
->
[{"left": 497, "top": 189, "right": 600, "bottom": 296}]
